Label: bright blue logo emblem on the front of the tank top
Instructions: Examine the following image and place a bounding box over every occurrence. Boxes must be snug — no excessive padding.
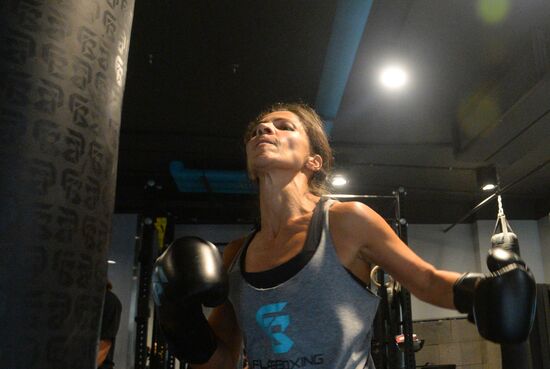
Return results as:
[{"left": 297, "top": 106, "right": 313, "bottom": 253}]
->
[{"left": 256, "top": 302, "right": 294, "bottom": 354}]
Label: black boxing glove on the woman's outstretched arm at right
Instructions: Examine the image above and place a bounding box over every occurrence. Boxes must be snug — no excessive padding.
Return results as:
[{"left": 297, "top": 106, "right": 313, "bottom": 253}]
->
[{"left": 453, "top": 248, "right": 536, "bottom": 343}]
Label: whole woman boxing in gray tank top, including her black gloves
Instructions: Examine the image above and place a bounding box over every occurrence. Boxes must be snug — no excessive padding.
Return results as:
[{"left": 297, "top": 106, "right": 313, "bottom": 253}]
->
[{"left": 154, "top": 104, "right": 534, "bottom": 369}]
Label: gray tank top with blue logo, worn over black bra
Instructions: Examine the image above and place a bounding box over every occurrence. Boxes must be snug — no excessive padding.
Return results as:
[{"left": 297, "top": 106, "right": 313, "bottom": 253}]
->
[{"left": 229, "top": 200, "right": 379, "bottom": 369}]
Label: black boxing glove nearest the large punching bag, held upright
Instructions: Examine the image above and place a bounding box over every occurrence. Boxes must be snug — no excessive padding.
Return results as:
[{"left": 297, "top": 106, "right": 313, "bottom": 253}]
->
[{"left": 152, "top": 237, "right": 228, "bottom": 364}]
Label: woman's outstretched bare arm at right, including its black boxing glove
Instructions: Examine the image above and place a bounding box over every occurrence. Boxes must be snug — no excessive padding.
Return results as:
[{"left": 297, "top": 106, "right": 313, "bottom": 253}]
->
[{"left": 331, "top": 203, "right": 536, "bottom": 343}]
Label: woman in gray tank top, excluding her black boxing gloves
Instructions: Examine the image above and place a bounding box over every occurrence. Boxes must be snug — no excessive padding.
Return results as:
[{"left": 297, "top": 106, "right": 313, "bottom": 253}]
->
[{"left": 197, "top": 104, "right": 459, "bottom": 368}]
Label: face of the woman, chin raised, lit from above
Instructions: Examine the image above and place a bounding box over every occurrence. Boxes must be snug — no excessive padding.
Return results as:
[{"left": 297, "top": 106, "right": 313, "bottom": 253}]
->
[{"left": 246, "top": 110, "right": 310, "bottom": 179}]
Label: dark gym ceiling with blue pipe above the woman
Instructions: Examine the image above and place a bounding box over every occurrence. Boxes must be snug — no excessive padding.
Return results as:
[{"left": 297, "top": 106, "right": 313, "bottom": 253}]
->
[{"left": 115, "top": 0, "right": 550, "bottom": 223}]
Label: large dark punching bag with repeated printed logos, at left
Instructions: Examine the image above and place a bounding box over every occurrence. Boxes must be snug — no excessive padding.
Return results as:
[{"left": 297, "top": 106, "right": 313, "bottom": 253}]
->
[{"left": 0, "top": 0, "right": 134, "bottom": 369}]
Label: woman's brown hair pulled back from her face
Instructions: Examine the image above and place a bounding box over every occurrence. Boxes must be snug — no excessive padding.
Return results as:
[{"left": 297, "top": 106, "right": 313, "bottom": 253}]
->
[{"left": 244, "top": 103, "right": 334, "bottom": 196}]
